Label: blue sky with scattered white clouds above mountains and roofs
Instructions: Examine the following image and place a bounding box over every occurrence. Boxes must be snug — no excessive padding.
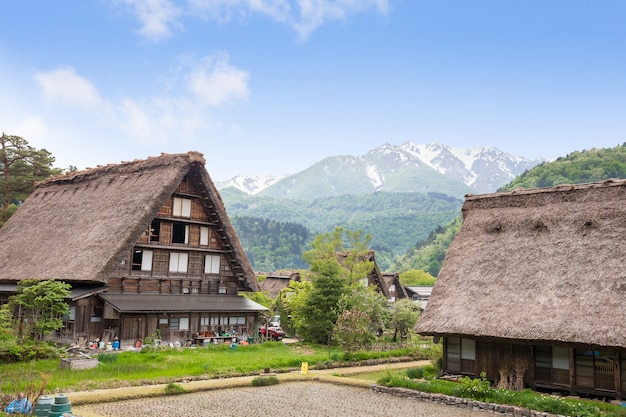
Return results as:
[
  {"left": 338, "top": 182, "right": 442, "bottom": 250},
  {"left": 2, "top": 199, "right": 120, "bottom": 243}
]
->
[{"left": 0, "top": 0, "right": 626, "bottom": 181}]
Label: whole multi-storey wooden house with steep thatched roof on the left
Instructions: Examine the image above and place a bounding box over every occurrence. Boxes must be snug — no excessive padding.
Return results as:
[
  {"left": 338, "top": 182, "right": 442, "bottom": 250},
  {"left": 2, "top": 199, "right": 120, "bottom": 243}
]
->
[{"left": 0, "top": 152, "right": 267, "bottom": 347}]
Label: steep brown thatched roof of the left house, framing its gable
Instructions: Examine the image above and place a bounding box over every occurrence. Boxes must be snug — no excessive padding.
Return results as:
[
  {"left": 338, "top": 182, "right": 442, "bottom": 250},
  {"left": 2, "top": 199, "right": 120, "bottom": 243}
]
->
[{"left": 0, "top": 152, "right": 258, "bottom": 291}]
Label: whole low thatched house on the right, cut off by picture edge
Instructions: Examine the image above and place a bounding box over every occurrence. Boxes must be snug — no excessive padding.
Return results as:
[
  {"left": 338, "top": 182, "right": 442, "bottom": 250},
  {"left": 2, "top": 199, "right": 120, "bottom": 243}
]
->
[{"left": 417, "top": 180, "right": 626, "bottom": 399}]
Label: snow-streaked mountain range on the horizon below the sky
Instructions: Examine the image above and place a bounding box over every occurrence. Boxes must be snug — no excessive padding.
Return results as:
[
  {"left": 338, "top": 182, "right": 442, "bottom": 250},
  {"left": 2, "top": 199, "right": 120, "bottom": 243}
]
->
[{"left": 216, "top": 141, "right": 545, "bottom": 200}]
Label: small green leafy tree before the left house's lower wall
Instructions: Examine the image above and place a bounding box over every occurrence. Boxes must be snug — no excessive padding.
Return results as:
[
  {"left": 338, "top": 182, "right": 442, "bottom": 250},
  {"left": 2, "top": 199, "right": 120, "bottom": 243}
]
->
[{"left": 9, "top": 279, "right": 71, "bottom": 341}]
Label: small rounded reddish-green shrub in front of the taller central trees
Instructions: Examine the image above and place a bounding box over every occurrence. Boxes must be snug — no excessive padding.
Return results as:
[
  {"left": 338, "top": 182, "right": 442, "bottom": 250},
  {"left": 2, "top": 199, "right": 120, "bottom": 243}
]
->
[{"left": 334, "top": 306, "right": 374, "bottom": 353}]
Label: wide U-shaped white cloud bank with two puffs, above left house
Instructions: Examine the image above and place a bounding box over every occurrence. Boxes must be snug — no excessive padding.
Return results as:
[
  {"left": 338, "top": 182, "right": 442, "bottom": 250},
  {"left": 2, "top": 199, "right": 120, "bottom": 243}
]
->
[{"left": 30, "top": 54, "right": 250, "bottom": 144}]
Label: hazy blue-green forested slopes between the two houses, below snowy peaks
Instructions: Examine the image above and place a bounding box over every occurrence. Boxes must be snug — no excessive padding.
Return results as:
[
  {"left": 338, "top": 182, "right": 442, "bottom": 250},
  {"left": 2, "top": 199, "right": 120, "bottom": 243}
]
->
[{"left": 221, "top": 189, "right": 462, "bottom": 272}]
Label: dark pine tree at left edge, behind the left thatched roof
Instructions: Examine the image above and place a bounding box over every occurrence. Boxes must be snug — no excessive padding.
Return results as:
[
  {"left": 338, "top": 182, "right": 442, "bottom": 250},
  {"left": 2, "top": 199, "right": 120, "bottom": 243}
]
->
[{"left": 0, "top": 133, "right": 62, "bottom": 223}]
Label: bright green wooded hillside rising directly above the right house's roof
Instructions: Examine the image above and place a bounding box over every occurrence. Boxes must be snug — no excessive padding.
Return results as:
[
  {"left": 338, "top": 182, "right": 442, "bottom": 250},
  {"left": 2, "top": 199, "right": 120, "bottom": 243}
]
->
[{"left": 499, "top": 143, "right": 626, "bottom": 191}]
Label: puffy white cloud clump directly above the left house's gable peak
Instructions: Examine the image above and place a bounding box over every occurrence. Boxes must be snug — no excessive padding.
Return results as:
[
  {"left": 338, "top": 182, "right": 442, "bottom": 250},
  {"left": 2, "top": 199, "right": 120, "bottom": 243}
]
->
[{"left": 188, "top": 56, "right": 250, "bottom": 107}]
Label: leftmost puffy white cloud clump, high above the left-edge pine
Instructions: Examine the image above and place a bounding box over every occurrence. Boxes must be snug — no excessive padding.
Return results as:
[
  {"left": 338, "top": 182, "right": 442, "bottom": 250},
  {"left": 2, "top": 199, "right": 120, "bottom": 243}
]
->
[{"left": 35, "top": 68, "right": 102, "bottom": 109}]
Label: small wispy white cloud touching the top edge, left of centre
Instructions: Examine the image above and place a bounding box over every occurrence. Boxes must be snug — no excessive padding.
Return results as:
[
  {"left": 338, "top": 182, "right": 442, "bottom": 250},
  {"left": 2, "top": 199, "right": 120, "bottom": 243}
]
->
[{"left": 117, "top": 0, "right": 183, "bottom": 41}]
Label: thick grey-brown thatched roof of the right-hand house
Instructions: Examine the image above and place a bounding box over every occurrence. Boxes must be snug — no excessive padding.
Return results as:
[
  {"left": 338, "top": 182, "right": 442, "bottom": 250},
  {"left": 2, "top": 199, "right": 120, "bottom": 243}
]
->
[{"left": 418, "top": 180, "right": 626, "bottom": 348}]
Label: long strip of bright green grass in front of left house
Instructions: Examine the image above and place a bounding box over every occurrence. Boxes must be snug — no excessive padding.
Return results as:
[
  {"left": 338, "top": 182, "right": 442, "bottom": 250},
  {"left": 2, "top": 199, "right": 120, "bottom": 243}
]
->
[{"left": 0, "top": 342, "right": 342, "bottom": 393}]
